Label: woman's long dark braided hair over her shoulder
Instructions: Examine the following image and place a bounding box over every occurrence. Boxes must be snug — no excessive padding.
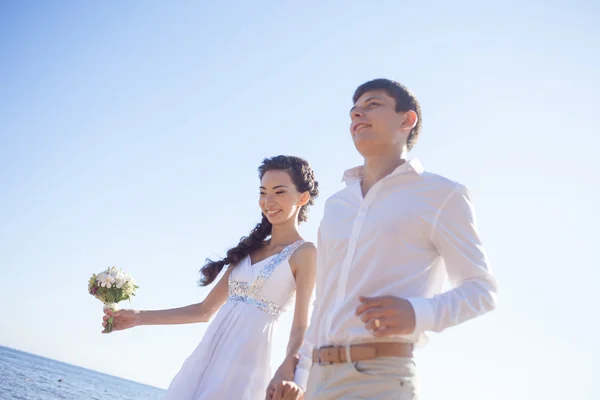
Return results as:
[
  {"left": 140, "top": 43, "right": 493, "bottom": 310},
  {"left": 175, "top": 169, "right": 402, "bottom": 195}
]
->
[{"left": 199, "top": 156, "right": 319, "bottom": 286}]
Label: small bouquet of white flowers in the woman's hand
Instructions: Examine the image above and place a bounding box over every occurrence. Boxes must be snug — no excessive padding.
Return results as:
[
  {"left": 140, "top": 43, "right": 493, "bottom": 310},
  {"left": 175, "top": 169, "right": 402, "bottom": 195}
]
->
[{"left": 88, "top": 266, "right": 138, "bottom": 332}]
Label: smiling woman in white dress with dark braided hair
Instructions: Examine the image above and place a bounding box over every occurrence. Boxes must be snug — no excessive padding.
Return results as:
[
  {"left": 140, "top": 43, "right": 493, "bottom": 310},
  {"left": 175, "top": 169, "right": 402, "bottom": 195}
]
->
[{"left": 102, "top": 156, "right": 319, "bottom": 400}]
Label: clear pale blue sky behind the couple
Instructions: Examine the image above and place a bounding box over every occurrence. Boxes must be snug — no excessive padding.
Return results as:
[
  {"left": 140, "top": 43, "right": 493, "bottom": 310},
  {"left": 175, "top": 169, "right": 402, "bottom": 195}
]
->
[{"left": 0, "top": 0, "right": 600, "bottom": 400}]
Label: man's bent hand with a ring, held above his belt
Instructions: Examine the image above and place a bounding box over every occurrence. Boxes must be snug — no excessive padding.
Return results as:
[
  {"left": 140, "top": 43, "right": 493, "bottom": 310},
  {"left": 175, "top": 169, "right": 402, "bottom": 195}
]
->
[{"left": 356, "top": 296, "right": 416, "bottom": 337}]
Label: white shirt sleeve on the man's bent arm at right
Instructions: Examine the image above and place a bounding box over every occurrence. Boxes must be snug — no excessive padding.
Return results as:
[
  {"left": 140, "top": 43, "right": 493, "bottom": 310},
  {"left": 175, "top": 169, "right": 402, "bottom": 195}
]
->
[{"left": 407, "top": 184, "right": 498, "bottom": 333}]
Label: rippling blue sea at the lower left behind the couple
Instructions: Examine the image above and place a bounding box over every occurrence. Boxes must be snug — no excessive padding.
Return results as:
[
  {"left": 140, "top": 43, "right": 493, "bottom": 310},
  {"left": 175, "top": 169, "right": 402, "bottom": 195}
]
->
[{"left": 0, "top": 346, "right": 165, "bottom": 400}]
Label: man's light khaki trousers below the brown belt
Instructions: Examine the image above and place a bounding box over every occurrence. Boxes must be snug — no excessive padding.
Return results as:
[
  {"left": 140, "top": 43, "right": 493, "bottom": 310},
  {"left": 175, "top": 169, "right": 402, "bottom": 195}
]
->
[{"left": 304, "top": 357, "right": 418, "bottom": 400}]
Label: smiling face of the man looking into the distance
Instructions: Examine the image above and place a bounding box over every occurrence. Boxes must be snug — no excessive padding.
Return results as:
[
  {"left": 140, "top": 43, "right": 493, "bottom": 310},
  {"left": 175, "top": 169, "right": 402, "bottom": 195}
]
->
[{"left": 350, "top": 90, "right": 410, "bottom": 157}]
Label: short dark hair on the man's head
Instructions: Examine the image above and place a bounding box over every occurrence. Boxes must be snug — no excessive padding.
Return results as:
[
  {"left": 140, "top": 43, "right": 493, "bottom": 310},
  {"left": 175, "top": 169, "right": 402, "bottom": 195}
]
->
[{"left": 352, "top": 78, "right": 422, "bottom": 150}]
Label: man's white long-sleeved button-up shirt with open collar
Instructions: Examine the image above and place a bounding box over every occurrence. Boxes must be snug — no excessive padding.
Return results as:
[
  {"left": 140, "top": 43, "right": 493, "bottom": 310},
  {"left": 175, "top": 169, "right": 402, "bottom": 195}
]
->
[{"left": 294, "top": 160, "right": 497, "bottom": 389}]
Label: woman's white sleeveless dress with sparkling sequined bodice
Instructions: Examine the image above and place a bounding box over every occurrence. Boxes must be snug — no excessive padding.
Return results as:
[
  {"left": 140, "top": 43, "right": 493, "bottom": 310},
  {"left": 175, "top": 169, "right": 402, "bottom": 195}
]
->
[{"left": 163, "top": 241, "right": 303, "bottom": 400}]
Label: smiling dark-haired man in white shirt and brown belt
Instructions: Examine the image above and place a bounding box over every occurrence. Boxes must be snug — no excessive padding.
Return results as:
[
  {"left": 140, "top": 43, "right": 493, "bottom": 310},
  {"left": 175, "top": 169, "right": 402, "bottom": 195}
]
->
[{"left": 273, "top": 79, "right": 497, "bottom": 400}]
